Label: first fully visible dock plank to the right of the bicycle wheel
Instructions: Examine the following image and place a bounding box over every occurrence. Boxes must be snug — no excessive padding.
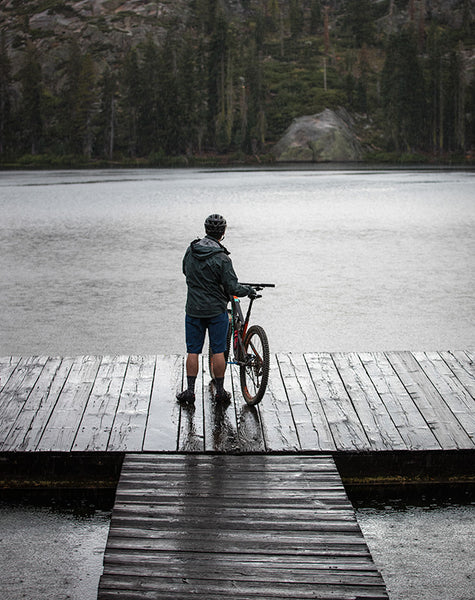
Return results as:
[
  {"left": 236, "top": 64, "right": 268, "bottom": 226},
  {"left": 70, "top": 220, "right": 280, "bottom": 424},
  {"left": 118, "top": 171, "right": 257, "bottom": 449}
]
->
[{"left": 277, "top": 354, "right": 335, "bottom": 451}]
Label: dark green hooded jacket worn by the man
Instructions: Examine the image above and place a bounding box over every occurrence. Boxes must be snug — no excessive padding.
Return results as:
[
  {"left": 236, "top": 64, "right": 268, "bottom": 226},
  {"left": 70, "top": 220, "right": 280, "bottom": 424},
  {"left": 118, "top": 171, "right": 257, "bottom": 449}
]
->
[{"left": 183, "top": 236, "right": 251, "bottom": 318}]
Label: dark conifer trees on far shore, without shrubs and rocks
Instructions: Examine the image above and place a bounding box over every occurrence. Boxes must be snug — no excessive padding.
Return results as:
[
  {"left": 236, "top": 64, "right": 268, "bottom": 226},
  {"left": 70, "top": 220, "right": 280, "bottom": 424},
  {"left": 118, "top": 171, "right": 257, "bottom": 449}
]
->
[{"left": 0, "top": 0, "right": 475, "bottom": 162}]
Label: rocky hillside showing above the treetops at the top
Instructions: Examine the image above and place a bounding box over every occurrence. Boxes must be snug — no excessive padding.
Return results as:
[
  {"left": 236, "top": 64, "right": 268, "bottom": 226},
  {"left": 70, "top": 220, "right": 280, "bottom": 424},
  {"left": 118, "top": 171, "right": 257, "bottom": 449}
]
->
[{"left": 0, "top": 0, "right": 473, "bottom": 77}]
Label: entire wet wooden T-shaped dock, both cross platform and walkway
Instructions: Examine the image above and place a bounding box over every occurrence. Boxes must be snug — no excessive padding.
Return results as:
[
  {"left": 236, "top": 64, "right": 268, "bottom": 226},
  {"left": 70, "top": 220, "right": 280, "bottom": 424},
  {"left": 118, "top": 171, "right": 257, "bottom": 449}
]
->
[{"left": 0, "top": 351, "right": 475, "bottom": 600}]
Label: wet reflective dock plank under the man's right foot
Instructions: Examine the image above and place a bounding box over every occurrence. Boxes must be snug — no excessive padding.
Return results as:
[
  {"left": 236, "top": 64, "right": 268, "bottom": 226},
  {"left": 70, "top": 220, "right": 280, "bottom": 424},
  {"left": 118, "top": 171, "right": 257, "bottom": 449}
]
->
[{"left": 203, "top": 356, "right": 240, "bottom": 452}]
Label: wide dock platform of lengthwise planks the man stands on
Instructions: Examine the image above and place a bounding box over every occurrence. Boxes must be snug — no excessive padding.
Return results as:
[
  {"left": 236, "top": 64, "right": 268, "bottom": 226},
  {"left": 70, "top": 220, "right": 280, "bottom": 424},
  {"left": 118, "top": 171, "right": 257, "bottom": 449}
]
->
[{"left": 0, "top": 351, "right": 475, "bottom": 455}]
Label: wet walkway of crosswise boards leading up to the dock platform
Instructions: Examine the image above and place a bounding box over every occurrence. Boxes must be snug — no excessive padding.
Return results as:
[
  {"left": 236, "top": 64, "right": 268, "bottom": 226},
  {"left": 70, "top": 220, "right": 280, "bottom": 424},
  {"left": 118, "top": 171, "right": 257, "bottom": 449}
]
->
[{"left": 98, "top": 454, "right": 388, "bottom": 600}]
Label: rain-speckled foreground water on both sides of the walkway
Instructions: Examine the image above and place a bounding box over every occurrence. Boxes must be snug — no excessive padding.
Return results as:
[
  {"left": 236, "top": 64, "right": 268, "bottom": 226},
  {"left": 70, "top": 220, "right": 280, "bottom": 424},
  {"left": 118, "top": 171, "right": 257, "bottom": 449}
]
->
[{"left": 0, "top": 498, "right": 475, "bottom": 600}]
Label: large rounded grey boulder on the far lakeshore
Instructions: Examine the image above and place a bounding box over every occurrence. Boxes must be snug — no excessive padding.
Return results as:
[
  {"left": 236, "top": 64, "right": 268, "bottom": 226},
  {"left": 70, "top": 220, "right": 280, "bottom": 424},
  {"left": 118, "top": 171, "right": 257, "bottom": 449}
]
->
[{"left": 272, "top": 108, "right": 363, "bottom": 162}]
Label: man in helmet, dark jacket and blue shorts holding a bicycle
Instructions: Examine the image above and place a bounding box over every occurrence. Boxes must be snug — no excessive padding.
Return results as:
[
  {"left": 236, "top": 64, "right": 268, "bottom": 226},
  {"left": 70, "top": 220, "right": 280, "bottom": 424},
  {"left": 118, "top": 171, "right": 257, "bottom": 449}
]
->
[{"left": 177, "top": 214, "right": 256, "bottom": 403}]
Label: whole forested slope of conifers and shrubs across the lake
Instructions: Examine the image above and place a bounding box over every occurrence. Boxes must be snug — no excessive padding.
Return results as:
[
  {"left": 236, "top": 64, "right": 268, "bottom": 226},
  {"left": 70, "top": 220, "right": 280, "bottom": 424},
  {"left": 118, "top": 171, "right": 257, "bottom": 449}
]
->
[{"left": 0, "top": 0, "right": 475, "bottom": 166}]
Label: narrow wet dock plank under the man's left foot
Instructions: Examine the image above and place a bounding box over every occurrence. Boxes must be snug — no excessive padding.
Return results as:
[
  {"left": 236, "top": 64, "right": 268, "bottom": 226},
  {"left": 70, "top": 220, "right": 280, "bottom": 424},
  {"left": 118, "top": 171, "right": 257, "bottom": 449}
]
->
[{"left": 175, "top": 356, "right": 203, "bottom": 452}]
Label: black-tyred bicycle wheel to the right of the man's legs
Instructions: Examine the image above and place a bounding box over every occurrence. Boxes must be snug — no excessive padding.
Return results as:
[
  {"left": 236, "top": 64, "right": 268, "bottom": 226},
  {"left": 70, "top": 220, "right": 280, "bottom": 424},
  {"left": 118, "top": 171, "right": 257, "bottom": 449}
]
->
[{"left": 240, "top": 325, "right": 270, "bottom": 406}]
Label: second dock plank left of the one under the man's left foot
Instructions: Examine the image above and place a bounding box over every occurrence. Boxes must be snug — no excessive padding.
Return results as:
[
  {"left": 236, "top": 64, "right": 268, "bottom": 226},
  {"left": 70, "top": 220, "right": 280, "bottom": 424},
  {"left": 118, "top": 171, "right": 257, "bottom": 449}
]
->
[{"left": 107, "top": 355, "right": 156, "bottom": 452}]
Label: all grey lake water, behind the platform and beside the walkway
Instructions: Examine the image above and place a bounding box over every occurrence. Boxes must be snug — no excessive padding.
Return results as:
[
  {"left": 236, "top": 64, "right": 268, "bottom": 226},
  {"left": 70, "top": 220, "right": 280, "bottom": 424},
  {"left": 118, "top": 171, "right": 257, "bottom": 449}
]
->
[{"left": 0, "top": 169, "right": 475, "bottom": 600}]
